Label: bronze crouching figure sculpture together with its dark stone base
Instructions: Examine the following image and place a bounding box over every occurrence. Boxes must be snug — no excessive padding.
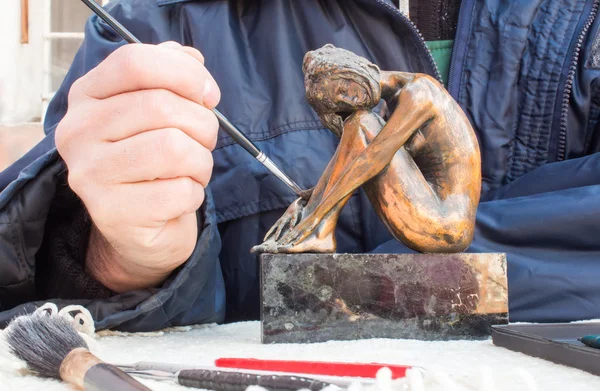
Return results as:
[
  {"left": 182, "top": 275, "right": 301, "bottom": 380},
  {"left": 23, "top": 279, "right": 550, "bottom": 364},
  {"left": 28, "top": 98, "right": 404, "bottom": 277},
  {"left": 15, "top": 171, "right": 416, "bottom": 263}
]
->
[{"left": 252, "top": 45, "right": 508, "bottom": 343}]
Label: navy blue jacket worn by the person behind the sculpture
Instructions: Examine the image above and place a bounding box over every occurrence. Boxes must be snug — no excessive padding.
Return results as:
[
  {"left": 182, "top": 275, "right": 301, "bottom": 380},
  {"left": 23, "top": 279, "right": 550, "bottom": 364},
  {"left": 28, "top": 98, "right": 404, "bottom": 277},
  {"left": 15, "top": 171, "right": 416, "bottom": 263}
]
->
[{"left": 0, "top": 0, "right": 600, "bottom": 331}]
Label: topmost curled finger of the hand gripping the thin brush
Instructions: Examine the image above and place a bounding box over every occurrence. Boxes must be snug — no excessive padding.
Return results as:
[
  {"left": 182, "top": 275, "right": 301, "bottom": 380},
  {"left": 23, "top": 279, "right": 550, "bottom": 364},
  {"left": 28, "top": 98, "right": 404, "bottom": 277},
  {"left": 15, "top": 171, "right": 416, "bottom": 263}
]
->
[{"left": 69, "top": 42, "right": 220, "bottom": 108}]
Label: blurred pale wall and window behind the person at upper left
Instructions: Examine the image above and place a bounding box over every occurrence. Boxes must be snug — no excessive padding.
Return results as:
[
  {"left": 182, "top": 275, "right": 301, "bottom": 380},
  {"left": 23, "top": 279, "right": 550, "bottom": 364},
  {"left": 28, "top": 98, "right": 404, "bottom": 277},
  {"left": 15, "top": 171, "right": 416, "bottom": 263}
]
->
[{"left": 0, "top": 0, "right": 108, "bottom": 171}]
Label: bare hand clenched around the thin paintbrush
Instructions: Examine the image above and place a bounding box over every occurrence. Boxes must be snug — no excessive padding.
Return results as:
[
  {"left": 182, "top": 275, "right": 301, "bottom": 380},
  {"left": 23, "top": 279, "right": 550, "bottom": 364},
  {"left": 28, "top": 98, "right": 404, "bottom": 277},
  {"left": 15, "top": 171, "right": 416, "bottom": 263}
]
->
[{"left": 55, "top": 42, "right": 220, "bottom": 292}]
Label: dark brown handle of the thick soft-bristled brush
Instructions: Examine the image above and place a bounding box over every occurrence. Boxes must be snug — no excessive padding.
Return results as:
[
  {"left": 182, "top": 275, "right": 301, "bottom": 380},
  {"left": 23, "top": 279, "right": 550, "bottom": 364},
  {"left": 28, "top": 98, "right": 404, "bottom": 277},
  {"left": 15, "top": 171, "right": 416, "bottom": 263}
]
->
[{"left": 83, "top": 363, "right": 152, "bottom": 391}]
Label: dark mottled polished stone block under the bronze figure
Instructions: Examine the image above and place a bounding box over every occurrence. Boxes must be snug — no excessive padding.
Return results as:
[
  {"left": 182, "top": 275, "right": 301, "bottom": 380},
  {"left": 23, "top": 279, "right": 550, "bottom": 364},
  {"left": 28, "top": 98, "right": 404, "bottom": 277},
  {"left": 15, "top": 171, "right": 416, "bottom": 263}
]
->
[{"left": 260, "top": 253, "right": 508, "bottom": 343}]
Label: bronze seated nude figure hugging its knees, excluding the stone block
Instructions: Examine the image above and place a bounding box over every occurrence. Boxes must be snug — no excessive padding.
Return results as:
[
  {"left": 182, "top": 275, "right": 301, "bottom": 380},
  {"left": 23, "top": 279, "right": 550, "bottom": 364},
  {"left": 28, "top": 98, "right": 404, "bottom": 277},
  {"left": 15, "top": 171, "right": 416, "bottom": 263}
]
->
[{"left": 251, "top": 44, "right": 481, "bottom": 253}]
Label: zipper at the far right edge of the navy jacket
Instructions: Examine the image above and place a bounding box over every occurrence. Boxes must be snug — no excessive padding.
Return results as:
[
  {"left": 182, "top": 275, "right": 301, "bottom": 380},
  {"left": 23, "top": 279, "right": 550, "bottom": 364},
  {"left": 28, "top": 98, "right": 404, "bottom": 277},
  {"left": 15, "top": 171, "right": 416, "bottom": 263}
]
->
[{"left": 556, "top": 0, "right": 600, "bottom": 161}]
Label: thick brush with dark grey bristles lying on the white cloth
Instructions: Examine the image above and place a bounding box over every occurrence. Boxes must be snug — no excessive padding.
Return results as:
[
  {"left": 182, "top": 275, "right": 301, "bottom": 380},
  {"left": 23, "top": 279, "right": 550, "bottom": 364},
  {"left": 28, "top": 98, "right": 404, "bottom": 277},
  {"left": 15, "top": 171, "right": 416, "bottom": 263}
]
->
[{"left": 5, "top": 313, "right": 150, "bottom": 391}]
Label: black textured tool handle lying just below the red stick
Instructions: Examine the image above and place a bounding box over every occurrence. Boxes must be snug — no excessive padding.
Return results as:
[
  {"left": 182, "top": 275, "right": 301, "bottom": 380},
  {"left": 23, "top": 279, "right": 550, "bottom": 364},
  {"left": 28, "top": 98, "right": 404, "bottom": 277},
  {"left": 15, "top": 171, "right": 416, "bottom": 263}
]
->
[{"left": 177, "top": 369, "right": 330, "bottom": 391}]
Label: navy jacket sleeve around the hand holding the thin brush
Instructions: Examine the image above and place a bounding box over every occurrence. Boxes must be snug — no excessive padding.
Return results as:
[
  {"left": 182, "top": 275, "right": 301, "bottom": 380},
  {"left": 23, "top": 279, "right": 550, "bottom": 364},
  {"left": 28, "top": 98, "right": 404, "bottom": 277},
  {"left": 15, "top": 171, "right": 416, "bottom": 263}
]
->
[{"left": 0, "top": 1, "right": 225, "bottom": 331}]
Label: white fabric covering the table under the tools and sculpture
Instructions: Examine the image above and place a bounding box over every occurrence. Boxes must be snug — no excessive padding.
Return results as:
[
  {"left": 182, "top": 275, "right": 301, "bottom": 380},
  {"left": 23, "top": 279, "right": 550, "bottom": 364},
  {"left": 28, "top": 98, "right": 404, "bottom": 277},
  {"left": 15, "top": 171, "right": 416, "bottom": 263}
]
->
[{"left": 0, "top": 322, "right": 600, "bottom": 391}]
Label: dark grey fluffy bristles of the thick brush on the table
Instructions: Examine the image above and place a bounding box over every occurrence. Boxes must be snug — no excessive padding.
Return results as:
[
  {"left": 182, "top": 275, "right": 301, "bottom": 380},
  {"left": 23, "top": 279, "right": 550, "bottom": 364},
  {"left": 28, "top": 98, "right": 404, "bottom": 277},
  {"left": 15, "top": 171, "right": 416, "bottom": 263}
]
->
[{"left": 6, "top": 314, "right": 88, "bottom": 379}]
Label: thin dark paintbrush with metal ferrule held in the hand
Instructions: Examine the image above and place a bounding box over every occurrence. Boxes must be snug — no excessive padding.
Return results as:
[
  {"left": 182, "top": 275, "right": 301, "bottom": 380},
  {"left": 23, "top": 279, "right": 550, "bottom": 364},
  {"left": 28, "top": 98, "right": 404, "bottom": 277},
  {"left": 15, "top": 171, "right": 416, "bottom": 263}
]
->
[{"left": 81, "top": 0, "right": 311, "bottom": 199}]
